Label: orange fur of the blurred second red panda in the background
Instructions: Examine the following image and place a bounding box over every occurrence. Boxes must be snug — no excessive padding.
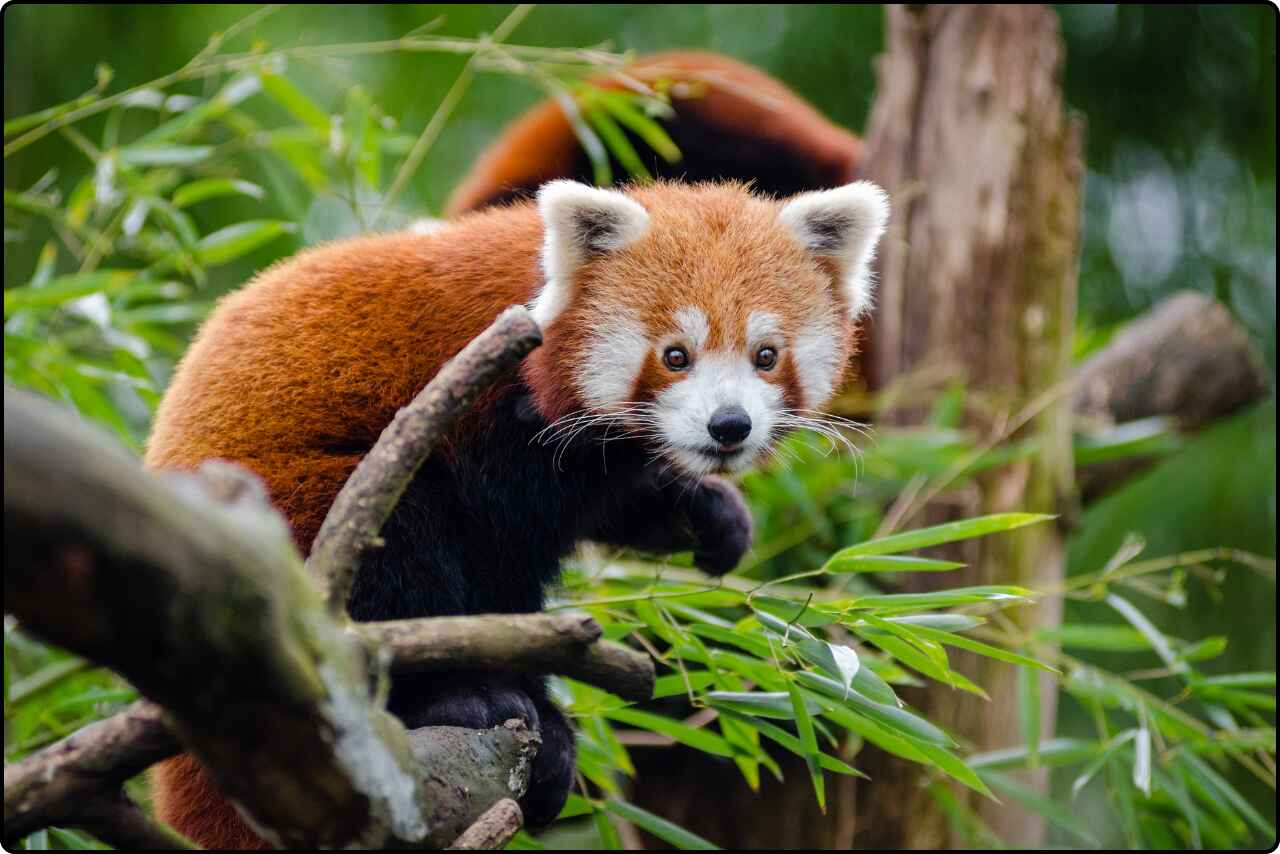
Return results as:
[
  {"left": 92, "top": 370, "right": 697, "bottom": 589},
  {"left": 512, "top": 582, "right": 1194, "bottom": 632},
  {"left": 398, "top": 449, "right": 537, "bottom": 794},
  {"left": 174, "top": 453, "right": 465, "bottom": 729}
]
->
[{"left": 445, "top": 51, "right": 863, "bottom": 216}]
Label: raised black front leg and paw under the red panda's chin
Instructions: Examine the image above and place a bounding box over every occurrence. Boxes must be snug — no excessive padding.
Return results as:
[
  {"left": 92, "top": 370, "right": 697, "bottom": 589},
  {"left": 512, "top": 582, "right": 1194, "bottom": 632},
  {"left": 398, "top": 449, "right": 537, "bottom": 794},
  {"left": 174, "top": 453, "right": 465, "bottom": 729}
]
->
[{"left": 584, "top": 476, "right": 753, "bottom": 575}]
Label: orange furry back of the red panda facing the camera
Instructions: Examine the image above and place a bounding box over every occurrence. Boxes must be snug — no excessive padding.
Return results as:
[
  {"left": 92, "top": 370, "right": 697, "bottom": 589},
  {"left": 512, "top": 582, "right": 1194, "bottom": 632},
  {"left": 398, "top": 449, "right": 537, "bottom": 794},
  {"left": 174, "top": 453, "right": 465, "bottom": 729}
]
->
[{"left": 146, "top": 206, "right": 541, "bottom": 551}]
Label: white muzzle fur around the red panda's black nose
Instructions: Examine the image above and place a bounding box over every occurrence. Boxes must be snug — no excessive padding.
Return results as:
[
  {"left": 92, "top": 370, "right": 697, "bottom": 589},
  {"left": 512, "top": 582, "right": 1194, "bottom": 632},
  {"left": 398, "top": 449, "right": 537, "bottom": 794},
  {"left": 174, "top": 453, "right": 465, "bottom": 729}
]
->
[{"left": 654, "top": 351, "right": 782, "bottom": 475}]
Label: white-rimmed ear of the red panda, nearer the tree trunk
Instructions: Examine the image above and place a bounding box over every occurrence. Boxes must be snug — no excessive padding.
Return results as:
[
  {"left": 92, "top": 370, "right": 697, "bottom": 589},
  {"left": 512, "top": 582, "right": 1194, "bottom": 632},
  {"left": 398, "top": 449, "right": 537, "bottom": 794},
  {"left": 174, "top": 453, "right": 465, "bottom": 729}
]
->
[{"left": 778, "top": 181, "right": 888, "bottom": 319}]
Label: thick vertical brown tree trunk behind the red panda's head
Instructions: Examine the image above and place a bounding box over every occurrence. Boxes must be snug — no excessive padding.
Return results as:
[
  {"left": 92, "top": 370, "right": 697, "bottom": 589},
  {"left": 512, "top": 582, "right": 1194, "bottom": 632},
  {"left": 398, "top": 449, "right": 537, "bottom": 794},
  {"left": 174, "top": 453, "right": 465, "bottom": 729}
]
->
[{"left": 856, "top": 5, "right": 1083, "bottom": 848}]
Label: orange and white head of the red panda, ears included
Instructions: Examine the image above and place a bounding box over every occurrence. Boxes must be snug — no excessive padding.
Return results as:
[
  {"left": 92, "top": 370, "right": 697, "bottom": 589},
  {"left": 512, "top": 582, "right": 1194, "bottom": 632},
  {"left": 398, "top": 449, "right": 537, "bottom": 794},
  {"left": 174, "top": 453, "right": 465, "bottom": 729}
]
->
[{"left": 532, "top": 182, "right": 887, "bottom": 476}]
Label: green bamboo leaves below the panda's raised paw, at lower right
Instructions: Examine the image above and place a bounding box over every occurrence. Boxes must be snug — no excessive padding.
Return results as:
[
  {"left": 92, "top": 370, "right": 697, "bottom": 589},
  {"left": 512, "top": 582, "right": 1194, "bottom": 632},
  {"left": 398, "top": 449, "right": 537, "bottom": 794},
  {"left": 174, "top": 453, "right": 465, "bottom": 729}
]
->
[{"left": 552, "top": 429, "right": 1275, "bottom": 848}]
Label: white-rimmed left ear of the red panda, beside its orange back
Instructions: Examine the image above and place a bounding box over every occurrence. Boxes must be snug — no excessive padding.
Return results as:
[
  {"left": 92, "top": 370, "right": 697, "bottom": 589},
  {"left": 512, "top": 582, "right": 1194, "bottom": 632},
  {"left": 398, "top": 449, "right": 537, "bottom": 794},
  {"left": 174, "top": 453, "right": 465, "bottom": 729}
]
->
[{"left": 530, "top": 181, "right": 649, "bottom": 329}]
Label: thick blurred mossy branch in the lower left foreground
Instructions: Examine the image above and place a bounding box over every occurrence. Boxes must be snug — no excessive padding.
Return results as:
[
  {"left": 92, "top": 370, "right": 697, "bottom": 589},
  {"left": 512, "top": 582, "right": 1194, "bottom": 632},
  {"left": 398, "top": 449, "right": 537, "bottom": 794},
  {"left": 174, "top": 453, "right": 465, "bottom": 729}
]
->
[{"left": 4, "top": 389, "right": 426, "bottom": 848}]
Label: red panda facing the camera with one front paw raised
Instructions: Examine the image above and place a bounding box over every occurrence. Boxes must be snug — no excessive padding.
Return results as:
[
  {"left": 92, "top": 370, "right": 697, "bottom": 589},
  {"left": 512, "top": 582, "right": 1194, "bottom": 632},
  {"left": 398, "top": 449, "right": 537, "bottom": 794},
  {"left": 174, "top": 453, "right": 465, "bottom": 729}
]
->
[{"left": 146, "top": 51, "right": 888, "bottom": 848}]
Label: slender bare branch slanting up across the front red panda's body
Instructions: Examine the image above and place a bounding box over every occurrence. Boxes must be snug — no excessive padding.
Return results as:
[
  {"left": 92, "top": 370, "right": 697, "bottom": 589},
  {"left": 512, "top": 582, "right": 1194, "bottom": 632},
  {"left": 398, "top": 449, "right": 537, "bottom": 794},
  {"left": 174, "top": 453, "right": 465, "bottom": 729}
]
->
[{"left": 307, "top": 306, "right": 543, "bottom": 613}]
